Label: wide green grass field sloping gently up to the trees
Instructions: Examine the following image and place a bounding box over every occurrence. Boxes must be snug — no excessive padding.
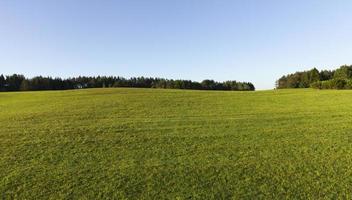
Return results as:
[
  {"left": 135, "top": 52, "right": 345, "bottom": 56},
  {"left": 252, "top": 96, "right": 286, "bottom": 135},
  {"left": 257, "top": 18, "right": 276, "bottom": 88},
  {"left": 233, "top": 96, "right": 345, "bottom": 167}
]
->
[{"left": 0, "top": 89, "right": 352, "bottom": 199}]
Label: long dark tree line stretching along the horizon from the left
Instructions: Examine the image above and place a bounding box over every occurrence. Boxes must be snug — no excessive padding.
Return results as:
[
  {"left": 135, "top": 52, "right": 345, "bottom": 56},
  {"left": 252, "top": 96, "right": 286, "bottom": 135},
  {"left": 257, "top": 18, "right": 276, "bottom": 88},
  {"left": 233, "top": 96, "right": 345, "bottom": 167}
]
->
[{"left": 0, "top": 74, "right": 255, "bottom": 92}]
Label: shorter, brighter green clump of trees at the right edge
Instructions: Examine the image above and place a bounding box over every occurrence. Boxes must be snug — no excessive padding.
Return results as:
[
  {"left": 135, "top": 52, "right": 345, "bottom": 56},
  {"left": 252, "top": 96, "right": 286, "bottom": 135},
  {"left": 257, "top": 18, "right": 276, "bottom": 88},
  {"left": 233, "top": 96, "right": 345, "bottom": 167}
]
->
[{"left": 276, "top": 65, "right": 352, "bottom": 89}]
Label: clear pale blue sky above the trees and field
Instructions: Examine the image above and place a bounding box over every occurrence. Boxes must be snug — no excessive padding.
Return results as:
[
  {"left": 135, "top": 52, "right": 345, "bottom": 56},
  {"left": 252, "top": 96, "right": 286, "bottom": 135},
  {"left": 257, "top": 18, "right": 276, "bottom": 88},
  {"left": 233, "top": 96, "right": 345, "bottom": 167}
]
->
[{"left": 0, "top": 0, "right": 352, "bottom": 89}]
